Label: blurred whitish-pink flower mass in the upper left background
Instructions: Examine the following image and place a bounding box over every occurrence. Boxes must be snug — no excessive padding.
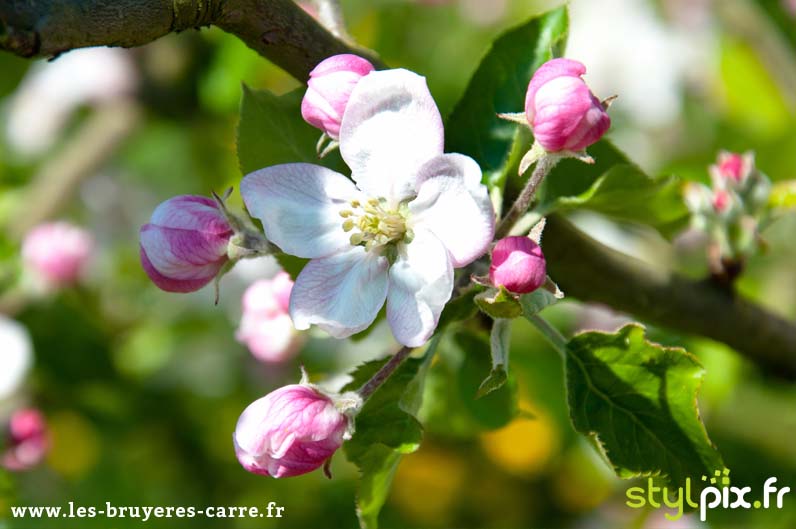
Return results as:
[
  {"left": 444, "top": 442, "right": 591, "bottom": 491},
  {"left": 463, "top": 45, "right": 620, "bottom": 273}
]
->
[{"left": 5, "top": 48, "right": 138, "bottom": 156}]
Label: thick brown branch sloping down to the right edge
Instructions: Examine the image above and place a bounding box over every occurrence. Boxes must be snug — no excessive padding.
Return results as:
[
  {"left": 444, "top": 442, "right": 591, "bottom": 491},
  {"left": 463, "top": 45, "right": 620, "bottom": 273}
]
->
[{"left": 543, "top": 215, "right": 796, "bottom": 380}]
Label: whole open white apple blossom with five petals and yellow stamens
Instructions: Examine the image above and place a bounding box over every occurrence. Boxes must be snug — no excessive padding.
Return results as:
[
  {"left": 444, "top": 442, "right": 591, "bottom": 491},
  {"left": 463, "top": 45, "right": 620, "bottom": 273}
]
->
[{"left": 241, "top": 69, "right": 495, "bottom": 347}]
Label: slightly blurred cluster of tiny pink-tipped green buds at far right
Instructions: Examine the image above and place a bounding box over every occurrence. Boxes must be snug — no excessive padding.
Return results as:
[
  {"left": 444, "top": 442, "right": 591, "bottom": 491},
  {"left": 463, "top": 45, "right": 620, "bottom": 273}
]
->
[{"left": 685, "top": 151, "right": 771, "bottom": 281}]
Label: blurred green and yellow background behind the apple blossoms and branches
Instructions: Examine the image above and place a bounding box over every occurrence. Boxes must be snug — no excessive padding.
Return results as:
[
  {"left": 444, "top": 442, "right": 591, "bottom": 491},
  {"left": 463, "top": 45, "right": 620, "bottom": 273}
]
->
[{"left": 0, "top": 0, "right": 796, "bottom": 529}]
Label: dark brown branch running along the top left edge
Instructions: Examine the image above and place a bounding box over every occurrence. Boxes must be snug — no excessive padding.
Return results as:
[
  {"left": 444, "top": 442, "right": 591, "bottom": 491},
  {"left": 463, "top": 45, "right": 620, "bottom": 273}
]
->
[{"left": 0, "top": 0, "right": 378, "bottom": 81}]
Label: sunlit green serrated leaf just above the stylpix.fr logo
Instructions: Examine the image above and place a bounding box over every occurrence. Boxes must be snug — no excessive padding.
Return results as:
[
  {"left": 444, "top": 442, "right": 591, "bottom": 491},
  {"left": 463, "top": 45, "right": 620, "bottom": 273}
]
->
[{"left": 566, "top": 324, "right": 724, "bottom": 486}]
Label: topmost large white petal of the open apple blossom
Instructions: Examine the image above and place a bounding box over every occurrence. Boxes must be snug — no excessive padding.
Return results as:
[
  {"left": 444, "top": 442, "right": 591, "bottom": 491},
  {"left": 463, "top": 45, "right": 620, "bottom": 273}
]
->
[{"left": 340, "top": 69, "right": 444, "bottom": 202}]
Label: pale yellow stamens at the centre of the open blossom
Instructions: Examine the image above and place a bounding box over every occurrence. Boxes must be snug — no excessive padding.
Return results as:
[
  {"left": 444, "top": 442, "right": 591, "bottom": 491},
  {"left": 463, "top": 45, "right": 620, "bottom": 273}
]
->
[{"left": 340, "top": 198, "right": 412, "bottom": 255}]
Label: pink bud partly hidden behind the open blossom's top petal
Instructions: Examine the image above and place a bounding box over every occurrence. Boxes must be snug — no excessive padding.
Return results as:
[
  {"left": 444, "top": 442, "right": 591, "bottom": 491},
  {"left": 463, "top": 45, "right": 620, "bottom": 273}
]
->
[{"left": 301, "top": 54, "right": 373, "bottom": 140}]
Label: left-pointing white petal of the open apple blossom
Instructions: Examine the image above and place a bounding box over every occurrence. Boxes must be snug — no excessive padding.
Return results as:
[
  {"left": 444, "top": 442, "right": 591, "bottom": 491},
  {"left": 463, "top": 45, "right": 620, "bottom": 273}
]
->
[{"left": 240, "top": 163, "right": 359, "bottom": 259}]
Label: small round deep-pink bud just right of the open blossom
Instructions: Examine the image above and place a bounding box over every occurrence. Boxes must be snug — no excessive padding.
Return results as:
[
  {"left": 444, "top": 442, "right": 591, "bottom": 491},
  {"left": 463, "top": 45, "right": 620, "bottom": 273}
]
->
[{"left": 489, "top": 237, "right": 547, "bottom": 294}]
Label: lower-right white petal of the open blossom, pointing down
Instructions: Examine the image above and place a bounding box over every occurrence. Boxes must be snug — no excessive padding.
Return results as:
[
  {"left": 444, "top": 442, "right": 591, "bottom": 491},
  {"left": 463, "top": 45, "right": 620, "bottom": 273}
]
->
[{"left": 387, "top": 231, "right": 453, "bottom": 347}]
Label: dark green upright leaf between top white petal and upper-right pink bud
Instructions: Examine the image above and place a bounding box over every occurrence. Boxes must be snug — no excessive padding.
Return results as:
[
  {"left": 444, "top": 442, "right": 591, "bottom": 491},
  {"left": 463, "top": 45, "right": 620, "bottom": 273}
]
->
[{"left": 445, "top": 7, "right": 568, "bottom": 188}]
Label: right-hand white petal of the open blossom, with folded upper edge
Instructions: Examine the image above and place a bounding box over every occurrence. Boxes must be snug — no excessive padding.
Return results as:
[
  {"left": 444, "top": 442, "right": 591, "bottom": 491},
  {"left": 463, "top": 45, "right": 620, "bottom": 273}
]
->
[{"left": 409, "top": 154, "right": 495, "bottom": 268}]
